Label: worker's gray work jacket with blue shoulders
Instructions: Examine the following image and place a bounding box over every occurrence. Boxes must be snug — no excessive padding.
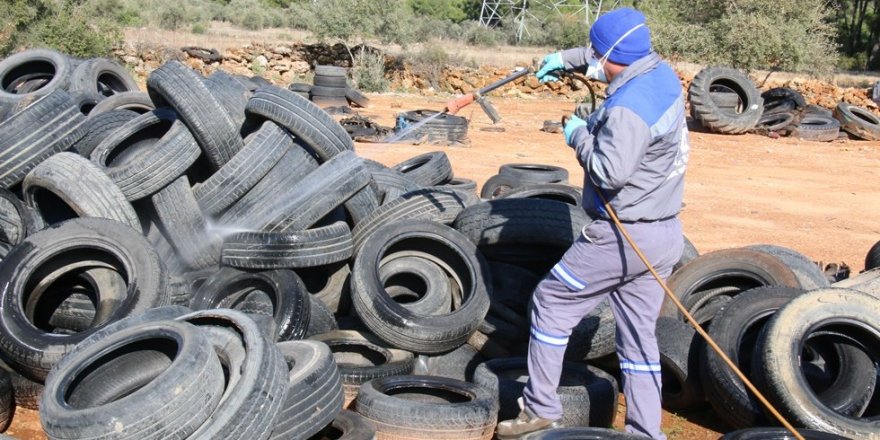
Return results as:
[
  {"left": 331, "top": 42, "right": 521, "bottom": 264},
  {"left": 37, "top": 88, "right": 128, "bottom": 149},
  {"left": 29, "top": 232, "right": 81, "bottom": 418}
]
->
[{"left": 562, "top": 48, "right": 689, "bottom": 222}]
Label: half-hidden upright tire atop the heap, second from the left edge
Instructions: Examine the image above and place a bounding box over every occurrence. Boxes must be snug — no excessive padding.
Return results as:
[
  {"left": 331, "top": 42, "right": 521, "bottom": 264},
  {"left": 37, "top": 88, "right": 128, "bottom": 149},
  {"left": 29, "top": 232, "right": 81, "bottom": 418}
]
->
[{"left": 68, "top": 58, "right": 138, "bottom": 98}]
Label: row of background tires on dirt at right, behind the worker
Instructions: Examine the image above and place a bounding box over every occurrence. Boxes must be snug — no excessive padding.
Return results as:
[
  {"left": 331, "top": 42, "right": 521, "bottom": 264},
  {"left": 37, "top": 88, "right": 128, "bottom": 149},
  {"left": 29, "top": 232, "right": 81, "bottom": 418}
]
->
[{"left": 688, "top": 67, "right": 880, "bottom": 141}]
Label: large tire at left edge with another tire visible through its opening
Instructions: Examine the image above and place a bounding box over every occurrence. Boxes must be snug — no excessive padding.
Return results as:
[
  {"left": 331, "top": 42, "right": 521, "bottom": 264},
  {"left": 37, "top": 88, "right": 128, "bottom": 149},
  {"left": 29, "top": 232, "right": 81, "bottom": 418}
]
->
[{"left": 0, "top": 218, "right": 168, "bottom": 380}]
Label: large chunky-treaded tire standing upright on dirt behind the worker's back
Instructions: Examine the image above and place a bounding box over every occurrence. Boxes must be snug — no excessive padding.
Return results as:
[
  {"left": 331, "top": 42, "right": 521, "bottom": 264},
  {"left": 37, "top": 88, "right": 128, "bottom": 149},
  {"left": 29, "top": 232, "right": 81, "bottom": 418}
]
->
[{"left": 688, "top": 67, "right": 764, "bottom": 134}]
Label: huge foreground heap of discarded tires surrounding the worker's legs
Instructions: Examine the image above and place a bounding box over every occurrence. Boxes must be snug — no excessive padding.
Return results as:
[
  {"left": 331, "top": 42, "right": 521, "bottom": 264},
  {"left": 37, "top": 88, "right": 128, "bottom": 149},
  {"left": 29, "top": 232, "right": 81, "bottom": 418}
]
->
[{"left": 0, "top": 49, "right": 880, "bottom": 440}]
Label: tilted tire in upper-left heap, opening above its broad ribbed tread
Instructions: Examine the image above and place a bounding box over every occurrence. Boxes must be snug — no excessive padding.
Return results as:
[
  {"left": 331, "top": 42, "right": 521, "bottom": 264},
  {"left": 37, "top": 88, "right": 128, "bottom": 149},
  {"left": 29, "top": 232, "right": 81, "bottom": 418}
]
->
[{"left": 90, "top": 109, "right": 202, "bottom": 201}]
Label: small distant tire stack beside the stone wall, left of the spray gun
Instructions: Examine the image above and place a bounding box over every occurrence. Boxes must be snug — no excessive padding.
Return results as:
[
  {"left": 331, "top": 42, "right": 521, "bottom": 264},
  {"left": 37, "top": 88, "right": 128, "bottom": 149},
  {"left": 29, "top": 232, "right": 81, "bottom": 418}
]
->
[{"left": 288, "top": 66, "right": 370, "bottom": 108}]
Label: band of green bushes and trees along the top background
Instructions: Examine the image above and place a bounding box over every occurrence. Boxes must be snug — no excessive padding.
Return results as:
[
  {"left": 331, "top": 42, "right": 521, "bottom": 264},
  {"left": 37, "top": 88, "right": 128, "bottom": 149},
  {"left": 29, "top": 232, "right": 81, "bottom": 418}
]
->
[{"left": 0, "top": 0, "right": 880, "bottom": 73}]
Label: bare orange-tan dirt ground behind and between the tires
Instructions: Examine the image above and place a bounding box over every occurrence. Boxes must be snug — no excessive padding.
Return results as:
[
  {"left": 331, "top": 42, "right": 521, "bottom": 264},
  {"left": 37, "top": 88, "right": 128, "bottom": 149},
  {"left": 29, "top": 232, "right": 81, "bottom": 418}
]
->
[{"left": 7, "top": 94, "right": 880, "bottom": 440}]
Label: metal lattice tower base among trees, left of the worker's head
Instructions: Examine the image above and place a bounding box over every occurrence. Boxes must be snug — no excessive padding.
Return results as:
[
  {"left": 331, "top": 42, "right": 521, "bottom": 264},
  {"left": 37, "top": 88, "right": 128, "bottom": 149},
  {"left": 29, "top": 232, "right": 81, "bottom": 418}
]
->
[{"left": 480, "top": 0, "right": 621, "bottom": 40}]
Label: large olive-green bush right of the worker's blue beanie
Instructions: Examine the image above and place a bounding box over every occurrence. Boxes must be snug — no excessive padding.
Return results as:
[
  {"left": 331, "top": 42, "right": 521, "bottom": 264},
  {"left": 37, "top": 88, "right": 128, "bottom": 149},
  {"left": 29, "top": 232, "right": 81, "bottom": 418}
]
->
[{"left": 644, "top": 0, "right": 836, "bottom": 73}]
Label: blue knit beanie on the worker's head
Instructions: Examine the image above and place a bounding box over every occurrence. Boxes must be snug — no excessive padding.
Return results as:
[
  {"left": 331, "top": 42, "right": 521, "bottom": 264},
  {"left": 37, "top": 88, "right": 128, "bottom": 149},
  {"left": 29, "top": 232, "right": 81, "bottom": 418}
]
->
[{"left": 590, "top": 8, "right": 651, "bottom": 66}]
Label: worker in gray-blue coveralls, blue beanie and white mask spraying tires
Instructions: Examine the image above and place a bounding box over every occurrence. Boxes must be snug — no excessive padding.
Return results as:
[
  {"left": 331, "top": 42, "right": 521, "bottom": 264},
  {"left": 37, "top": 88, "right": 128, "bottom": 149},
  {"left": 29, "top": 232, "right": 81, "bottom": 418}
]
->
[{"left": 497, "top": 8, "right": 688, "bottom": 439}]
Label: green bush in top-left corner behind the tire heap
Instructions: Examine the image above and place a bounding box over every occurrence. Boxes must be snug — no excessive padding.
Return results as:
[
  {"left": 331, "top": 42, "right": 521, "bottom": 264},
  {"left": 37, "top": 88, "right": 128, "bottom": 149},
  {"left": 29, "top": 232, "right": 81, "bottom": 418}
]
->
[{"left": 0, "top": 0, "right": 122, "bottom": 57}]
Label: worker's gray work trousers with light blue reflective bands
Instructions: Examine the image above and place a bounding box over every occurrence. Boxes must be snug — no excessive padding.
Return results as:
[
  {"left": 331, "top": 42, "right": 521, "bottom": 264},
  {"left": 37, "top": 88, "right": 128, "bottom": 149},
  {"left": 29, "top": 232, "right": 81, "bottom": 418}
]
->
[{"left": 523, "top": 218, "right": 684, "bottom": 439}]
